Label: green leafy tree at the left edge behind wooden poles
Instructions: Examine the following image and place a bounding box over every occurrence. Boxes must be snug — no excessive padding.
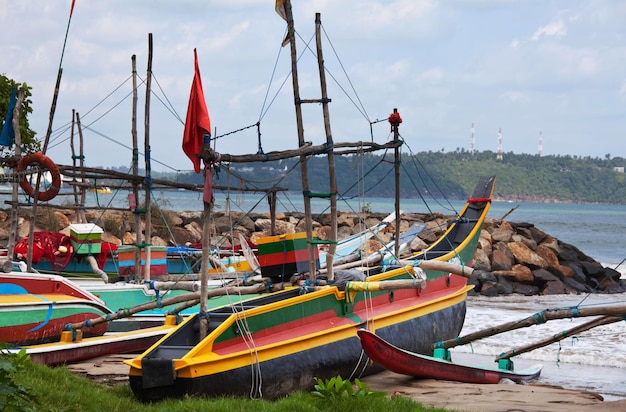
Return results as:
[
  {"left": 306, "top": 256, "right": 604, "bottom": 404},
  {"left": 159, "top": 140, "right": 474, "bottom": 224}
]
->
[{"left": 0, "top": 74, "right": 41, "bottom": 159}]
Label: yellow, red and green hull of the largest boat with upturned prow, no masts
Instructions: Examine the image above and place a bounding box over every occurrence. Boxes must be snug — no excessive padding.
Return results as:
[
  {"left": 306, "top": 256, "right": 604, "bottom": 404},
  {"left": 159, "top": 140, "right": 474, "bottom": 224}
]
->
[{"left": 127, "top": 177, "right": 495, "bottom": 401}]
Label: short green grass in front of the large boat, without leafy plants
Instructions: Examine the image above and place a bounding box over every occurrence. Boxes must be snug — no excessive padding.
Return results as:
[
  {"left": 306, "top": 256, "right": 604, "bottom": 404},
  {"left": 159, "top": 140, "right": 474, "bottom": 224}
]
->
[{"left": 8, "top": 355, "right": 454, "bottom": 412}]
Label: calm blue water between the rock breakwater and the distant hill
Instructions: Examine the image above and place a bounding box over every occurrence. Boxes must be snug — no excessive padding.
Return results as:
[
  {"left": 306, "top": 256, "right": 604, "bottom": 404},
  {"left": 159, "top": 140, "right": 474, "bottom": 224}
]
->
[{"left": 64, "top": 190, "right": 626, "bottom": 271}]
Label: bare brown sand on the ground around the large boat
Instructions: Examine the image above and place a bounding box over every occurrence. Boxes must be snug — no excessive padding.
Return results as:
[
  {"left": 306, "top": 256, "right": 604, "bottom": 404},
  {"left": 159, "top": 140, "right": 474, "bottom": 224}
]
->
[{"left": 68, "top": 355, "right": 626, "bottom": 412}]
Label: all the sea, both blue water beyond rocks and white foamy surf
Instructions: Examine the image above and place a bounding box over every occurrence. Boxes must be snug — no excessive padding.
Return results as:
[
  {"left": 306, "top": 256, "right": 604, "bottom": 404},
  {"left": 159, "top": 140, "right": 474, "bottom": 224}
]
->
[{"left": 13, "top": 190, "right": 626, "bottom": 400}]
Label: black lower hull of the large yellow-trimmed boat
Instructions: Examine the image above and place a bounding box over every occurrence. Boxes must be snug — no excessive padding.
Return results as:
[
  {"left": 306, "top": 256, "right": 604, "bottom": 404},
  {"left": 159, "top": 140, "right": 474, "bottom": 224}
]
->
[{"left": 129, "top": 302, "right": 465, "bottom": 402}]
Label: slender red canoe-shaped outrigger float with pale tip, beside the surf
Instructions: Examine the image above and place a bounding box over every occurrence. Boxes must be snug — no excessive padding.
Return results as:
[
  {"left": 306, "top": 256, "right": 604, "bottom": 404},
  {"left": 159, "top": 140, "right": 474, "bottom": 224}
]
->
[{"left": 357, "top": 329, "right": 542, "bottom": 384}]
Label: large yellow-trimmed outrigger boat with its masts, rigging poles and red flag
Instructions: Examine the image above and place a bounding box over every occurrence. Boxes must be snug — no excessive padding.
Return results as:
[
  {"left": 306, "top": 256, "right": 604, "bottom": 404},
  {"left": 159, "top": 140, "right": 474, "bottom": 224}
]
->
[{"left": 126, "top": 0, "right": 495, "bottom": 402}]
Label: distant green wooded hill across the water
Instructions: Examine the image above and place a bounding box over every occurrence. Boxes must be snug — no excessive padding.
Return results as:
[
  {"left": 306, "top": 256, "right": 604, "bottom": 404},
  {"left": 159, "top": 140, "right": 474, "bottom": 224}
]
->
[{"left": 113, "top": 150, "right": 626, "bottom": 204}]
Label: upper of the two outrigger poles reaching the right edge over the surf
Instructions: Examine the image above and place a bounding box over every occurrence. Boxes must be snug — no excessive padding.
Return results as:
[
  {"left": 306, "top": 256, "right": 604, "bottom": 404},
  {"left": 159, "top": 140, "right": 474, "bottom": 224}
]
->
[{"left": 434, "top": 304, "right": 626, "bottom": 349}]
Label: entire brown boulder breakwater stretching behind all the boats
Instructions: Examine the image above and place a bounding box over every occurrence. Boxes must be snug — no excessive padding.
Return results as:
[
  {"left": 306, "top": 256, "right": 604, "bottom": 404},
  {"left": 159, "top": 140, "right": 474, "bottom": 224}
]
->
[{"left": 0, "top": 208, "right": 626, "bottom": 296}]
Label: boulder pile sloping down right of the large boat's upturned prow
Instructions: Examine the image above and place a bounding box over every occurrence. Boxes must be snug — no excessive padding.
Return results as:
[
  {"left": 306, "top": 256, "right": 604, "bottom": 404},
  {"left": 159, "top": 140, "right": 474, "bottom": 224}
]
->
[{"left": 469, "top": 219, "right": 626, "bottom": 296}]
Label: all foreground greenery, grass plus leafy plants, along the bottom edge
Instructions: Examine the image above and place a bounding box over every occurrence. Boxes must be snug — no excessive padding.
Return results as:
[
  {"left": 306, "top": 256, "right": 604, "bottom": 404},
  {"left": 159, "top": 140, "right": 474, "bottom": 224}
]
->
[{"left": 0, "top": 351, "right": 454, "bottom": 412}]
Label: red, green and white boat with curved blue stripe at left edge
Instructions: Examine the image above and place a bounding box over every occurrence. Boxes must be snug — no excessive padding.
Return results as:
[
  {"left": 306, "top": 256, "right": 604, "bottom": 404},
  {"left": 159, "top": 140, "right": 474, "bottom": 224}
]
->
[{"left": 0, "top": 280, "right": 111, "bottom": 345}]
